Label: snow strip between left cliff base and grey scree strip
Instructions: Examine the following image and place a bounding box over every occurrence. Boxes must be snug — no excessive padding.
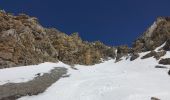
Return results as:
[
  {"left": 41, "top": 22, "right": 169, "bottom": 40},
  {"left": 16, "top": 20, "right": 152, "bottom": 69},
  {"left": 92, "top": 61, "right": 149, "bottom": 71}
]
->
[{"left": 0, "top": 62, "right": 67, "bottom": 85}]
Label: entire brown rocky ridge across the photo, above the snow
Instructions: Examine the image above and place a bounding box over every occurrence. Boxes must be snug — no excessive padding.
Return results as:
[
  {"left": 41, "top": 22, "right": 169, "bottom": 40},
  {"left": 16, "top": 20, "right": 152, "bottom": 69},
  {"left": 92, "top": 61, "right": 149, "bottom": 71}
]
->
[{"left": 0, "top": 11, "right": 170, "bottom": 68}]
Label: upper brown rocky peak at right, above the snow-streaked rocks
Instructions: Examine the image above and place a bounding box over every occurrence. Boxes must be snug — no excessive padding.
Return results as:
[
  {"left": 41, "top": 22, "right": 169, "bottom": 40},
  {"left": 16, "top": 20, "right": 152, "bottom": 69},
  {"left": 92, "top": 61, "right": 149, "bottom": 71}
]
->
[{"left": 133, "top": 17, "right": 170, "bottom": 52}]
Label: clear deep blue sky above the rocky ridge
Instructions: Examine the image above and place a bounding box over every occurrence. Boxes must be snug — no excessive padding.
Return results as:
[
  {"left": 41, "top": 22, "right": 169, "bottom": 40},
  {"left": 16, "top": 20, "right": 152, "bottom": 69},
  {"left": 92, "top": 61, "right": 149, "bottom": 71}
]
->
[{"left": 0, "top": 0, "right": 170, "bottom": 45}]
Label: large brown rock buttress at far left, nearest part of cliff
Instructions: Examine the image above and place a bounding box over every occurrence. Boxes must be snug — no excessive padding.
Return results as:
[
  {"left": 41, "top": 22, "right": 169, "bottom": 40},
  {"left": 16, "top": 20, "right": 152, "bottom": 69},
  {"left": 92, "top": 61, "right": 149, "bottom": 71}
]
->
[{"left": 0, "top": 12, "right": 57, "bottom": 68}]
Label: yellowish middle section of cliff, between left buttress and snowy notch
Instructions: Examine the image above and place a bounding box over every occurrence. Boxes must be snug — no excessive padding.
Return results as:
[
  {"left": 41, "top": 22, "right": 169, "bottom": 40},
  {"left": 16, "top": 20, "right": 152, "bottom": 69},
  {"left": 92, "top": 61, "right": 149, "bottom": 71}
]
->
[{"left": 46, "top": 29, "right": 116, "bottom": 65}]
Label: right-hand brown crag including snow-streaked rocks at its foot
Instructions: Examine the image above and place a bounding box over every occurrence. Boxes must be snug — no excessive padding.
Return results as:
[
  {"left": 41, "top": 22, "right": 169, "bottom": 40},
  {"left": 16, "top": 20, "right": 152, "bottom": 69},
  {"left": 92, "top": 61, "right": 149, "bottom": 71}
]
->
[{"left": 131, "top": 17, "right": 170, "bottom": 64}]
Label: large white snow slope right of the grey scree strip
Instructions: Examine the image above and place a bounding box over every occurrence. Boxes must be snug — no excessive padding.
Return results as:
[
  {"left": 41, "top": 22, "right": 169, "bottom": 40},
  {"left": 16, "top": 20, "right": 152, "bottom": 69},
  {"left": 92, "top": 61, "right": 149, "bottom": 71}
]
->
[{"left": 14, "top": 53, "right": 170, "bottom": 100}]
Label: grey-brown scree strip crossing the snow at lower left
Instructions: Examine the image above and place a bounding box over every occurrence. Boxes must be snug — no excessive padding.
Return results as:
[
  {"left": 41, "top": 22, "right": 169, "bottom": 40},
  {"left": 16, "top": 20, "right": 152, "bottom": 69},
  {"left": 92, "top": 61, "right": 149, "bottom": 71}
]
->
[{"left": 0, "top": 67, "right": 67, "bottom": 100}]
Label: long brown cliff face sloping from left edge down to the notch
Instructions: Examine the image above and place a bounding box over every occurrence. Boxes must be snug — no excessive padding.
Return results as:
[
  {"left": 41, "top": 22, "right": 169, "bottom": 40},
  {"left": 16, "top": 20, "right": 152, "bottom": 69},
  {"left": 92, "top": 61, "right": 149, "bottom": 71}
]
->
[{"left": 0, "top": 11, "right": 115, "bottom": 68}]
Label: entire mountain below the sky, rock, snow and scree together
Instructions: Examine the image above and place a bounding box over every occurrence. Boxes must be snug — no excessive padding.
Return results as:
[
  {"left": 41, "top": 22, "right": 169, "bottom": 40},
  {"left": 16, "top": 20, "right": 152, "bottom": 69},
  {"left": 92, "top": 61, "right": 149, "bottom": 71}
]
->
[{"left": 0, "top": 11, "right": 170, "bottom": 100}]
